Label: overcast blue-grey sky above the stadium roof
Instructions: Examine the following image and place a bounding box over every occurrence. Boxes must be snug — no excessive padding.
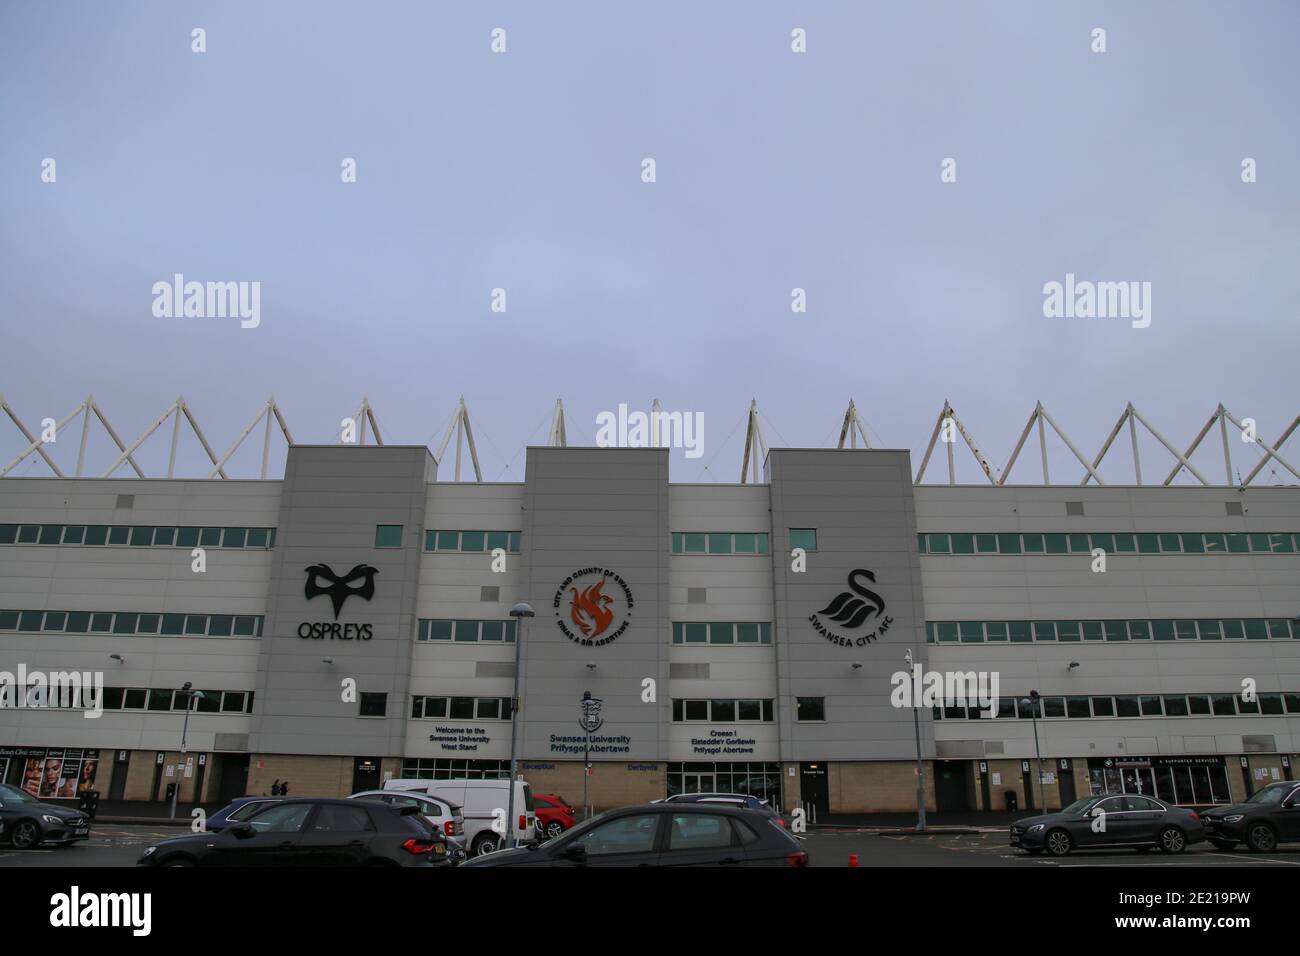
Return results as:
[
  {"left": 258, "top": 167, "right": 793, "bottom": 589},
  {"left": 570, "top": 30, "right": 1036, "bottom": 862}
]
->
[{"left": 0, "top": 0, "right": 1300, "bottom": 484}]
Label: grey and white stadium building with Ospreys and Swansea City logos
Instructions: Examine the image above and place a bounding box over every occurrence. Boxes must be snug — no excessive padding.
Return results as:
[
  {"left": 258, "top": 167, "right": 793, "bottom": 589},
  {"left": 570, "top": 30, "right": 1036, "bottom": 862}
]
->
[{"left": 0, "top": 399, "right": 1300, "bottom": 816}]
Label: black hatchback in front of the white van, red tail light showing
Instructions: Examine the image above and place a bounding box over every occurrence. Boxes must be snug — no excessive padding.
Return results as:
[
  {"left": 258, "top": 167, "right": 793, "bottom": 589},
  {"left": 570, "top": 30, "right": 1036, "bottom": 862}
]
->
[{"left": 138, "top": 799, "right": 447, "bottom": 866}]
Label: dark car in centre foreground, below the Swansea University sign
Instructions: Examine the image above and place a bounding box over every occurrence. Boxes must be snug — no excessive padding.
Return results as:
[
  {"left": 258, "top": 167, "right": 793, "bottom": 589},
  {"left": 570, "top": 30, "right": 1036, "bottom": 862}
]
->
[{"left": 463, "top": 803, "right": 809, "bottom": 866}]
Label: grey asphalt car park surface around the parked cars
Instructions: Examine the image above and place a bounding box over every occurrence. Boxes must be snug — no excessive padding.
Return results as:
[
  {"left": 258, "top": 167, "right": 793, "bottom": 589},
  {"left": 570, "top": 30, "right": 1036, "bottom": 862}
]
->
[{"left": 0, "top": 823, "right": 1300, "bottom": 868}]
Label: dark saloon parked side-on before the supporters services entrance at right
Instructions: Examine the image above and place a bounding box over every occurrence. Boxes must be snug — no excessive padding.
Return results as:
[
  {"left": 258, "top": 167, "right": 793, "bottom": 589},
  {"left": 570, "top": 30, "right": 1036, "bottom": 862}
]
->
[{"left": 1011, "top": 793, "right": 1205, "bottom": 856}]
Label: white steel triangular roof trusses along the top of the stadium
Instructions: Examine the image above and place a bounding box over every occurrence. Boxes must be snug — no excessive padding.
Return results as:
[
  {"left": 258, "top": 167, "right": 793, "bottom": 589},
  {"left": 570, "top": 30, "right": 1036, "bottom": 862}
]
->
[{"left": 0, "top": 395, "right": 1300, "bottom": 488}]
